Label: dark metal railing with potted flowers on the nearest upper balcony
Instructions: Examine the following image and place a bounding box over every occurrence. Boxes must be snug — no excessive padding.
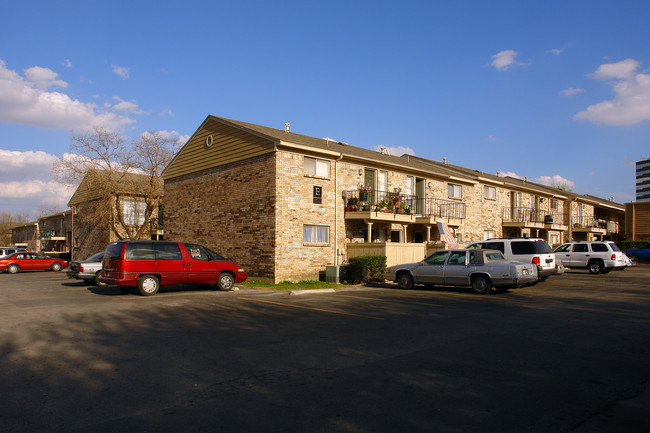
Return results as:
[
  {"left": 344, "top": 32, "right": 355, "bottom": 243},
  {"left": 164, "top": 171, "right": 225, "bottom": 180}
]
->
[{"left": 345, "top": 190, "right": 467, "bottom": 219}]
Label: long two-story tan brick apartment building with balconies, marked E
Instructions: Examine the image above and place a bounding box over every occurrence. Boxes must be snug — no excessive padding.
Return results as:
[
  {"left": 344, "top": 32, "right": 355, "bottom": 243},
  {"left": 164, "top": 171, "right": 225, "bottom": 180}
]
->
[{"left": 163, "top": 116, "right": 625, "bottom": 282}]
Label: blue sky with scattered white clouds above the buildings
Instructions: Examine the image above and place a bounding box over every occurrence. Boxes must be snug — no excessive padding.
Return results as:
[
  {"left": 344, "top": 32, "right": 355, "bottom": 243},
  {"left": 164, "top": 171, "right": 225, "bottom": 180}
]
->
[{"left": 0, "top": 0, "right": 650, "bottom": 218}]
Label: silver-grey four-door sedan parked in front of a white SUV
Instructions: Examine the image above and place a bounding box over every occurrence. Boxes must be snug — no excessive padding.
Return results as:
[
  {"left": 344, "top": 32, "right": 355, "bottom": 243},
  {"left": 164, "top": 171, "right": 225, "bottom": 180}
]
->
[{"left": 385, "top": 249, "right": 537, "bottom": 294}]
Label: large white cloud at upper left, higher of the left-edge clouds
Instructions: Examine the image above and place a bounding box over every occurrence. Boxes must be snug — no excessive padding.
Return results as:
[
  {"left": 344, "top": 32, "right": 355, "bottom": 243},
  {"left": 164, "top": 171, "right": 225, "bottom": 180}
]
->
[{"left": 0, "top": 59, "right": 135, "bottom": 131}]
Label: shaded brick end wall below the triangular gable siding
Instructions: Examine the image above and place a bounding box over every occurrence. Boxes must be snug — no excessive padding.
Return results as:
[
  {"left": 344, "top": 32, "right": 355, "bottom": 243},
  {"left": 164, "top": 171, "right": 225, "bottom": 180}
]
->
[{"left": 164, "top": 154, "right": 274, "bottom": 279}]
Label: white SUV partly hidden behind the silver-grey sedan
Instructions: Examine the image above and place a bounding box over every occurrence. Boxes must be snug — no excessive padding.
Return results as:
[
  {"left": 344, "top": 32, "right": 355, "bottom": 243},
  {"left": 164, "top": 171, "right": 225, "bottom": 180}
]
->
[{"left": 467, "top": 238, "right": 564, "bottom": 281}]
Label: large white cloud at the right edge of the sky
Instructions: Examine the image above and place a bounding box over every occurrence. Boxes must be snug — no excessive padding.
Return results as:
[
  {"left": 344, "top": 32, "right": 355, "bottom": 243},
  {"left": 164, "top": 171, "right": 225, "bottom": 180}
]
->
[{"left": 573, "top": 59, "right": 650, "bottom": 126}]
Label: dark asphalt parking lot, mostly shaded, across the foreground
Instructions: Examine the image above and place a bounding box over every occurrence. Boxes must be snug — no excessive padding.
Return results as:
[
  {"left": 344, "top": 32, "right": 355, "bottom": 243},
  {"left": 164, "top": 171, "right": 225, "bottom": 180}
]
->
[{"left": 0, "top": 264, "right": 650, "bottom": 433}]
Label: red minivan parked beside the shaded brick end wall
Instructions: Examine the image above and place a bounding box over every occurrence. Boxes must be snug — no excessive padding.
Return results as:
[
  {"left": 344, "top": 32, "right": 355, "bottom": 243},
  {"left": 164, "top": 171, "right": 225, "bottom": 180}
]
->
[{"left": 99, "top": 240, "right": 248, "bottom": 296}]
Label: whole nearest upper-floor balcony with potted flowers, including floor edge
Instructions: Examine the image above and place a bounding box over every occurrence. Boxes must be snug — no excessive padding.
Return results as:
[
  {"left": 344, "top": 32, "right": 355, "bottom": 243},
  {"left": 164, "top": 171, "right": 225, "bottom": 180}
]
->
[{"left": 344, "top": 190, "right": 466, "bottom": 225}]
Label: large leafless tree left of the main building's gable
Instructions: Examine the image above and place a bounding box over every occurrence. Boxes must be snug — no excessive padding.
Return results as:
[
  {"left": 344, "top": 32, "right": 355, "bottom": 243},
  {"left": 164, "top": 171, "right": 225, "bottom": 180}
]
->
[{"left": 54, "top": 128, "right": 173, "bottom": 245}]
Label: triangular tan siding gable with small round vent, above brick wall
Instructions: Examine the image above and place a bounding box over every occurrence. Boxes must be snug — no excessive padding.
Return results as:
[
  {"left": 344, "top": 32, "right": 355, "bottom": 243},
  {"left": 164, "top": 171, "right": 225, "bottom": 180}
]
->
[{"left": 163, "top": 119, "right": 274, "bottom": 180}]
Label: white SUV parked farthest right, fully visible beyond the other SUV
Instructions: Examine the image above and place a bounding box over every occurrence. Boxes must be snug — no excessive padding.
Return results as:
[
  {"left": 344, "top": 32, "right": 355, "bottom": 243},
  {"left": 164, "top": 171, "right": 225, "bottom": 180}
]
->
[{"left": 555, "top": 241, "right": 627, "bottom": 274}]
